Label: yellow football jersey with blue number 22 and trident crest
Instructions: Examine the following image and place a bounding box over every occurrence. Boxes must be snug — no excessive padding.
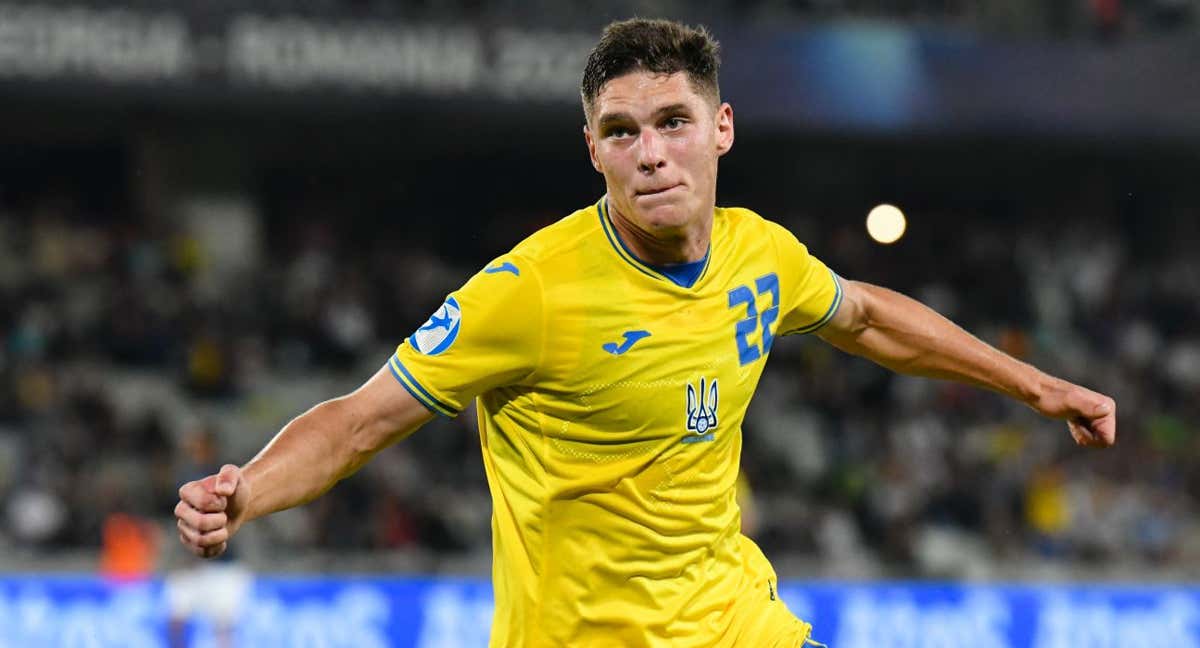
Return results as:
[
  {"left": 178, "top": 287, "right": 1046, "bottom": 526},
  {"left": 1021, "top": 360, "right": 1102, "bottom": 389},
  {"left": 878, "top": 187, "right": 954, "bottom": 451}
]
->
[{"left": 391, "top": 199, "right": 841, "bottom": 648}]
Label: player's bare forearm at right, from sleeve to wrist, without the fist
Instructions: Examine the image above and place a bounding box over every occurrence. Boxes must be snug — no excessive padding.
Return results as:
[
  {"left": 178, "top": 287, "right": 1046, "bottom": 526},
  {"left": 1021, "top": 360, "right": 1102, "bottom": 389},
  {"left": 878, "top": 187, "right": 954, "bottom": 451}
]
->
[{"left": 822, "top": 282, "right": 1062, "bottom": 404}]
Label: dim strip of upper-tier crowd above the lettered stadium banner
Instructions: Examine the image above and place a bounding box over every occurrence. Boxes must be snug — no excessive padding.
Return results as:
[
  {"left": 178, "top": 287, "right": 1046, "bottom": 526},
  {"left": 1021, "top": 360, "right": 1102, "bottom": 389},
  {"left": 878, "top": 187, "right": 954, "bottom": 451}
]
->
[{"left": 82, "top": 0, "right": 1198, "bottom": 40}]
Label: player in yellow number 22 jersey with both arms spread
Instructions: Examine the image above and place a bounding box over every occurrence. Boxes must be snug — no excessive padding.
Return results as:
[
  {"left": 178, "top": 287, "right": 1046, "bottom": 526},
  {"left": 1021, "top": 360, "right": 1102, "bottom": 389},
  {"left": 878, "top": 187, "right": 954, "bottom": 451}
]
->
[{"left": 175, "top": 19, "right": 1116, "bottom": 648}]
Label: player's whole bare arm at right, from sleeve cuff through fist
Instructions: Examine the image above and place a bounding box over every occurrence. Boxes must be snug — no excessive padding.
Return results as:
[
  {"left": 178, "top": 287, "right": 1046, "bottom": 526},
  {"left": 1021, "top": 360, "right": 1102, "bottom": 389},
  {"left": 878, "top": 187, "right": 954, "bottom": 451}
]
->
[{"left": 817, "top": 280, "right": 1117, "bottom": 446}]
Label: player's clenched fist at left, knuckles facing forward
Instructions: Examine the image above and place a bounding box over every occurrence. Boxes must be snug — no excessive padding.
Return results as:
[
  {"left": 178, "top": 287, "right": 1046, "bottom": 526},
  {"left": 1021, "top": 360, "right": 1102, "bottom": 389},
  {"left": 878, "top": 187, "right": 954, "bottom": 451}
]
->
[{"left": 175, "top": 463, "right": 250, "bottom": 558}]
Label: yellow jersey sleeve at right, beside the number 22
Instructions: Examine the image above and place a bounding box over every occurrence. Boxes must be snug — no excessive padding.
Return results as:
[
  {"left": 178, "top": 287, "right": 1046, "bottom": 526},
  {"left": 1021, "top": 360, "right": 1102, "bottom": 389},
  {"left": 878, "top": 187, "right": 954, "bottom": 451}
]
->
[{"left": 773, "top": 223, "right": 841, "bottom": 335}]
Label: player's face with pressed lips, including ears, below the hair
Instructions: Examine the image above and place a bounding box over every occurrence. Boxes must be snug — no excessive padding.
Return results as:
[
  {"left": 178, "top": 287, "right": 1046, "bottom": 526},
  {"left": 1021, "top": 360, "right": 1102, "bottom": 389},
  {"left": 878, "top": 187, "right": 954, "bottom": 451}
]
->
[{"left": 583, "top": 72, "right": 733, "bottom": 238}]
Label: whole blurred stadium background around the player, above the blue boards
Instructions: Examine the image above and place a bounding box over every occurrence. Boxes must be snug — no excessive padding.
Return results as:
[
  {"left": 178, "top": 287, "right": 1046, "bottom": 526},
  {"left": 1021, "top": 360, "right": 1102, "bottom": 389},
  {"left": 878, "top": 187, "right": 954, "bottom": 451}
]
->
[{"left": 0, "top": 0, "right": 1200, "bottom": 646}]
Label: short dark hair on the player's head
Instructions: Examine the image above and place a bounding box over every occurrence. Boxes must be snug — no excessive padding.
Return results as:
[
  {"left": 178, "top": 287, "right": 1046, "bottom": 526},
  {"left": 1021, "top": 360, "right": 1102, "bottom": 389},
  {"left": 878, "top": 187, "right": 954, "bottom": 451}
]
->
[{"left": 580, "top": 18, "right": 721, "bottom": 119}]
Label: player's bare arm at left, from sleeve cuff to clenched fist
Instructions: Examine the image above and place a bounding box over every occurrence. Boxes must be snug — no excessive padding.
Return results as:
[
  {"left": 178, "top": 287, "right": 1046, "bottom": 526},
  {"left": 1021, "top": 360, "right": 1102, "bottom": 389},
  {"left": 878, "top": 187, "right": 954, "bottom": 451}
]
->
[{"left": 175, "top": 366, "right": 433, "bottom": 558}]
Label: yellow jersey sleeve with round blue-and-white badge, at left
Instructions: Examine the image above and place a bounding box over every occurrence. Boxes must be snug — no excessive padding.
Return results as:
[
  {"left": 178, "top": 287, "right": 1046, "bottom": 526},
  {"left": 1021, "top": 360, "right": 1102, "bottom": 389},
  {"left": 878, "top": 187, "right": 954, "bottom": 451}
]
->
[{"left": 388, "top": 254, "right": 544, "bottom": 416}]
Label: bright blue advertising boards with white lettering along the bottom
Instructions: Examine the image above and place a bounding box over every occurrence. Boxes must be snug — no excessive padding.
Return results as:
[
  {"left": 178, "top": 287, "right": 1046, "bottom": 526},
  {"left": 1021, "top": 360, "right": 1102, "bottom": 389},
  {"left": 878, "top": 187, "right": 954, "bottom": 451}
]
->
[{"left": 0, "top": 577, "right": 1200, "bottom": 648}]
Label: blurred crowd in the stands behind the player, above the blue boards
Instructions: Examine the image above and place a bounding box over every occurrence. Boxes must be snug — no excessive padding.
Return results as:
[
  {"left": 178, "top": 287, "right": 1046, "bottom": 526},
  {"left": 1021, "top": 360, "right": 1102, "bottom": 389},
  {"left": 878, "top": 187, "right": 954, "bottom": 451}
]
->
[{"left": 0, "top": 163, "right": 1200, "bottom": 577}]
